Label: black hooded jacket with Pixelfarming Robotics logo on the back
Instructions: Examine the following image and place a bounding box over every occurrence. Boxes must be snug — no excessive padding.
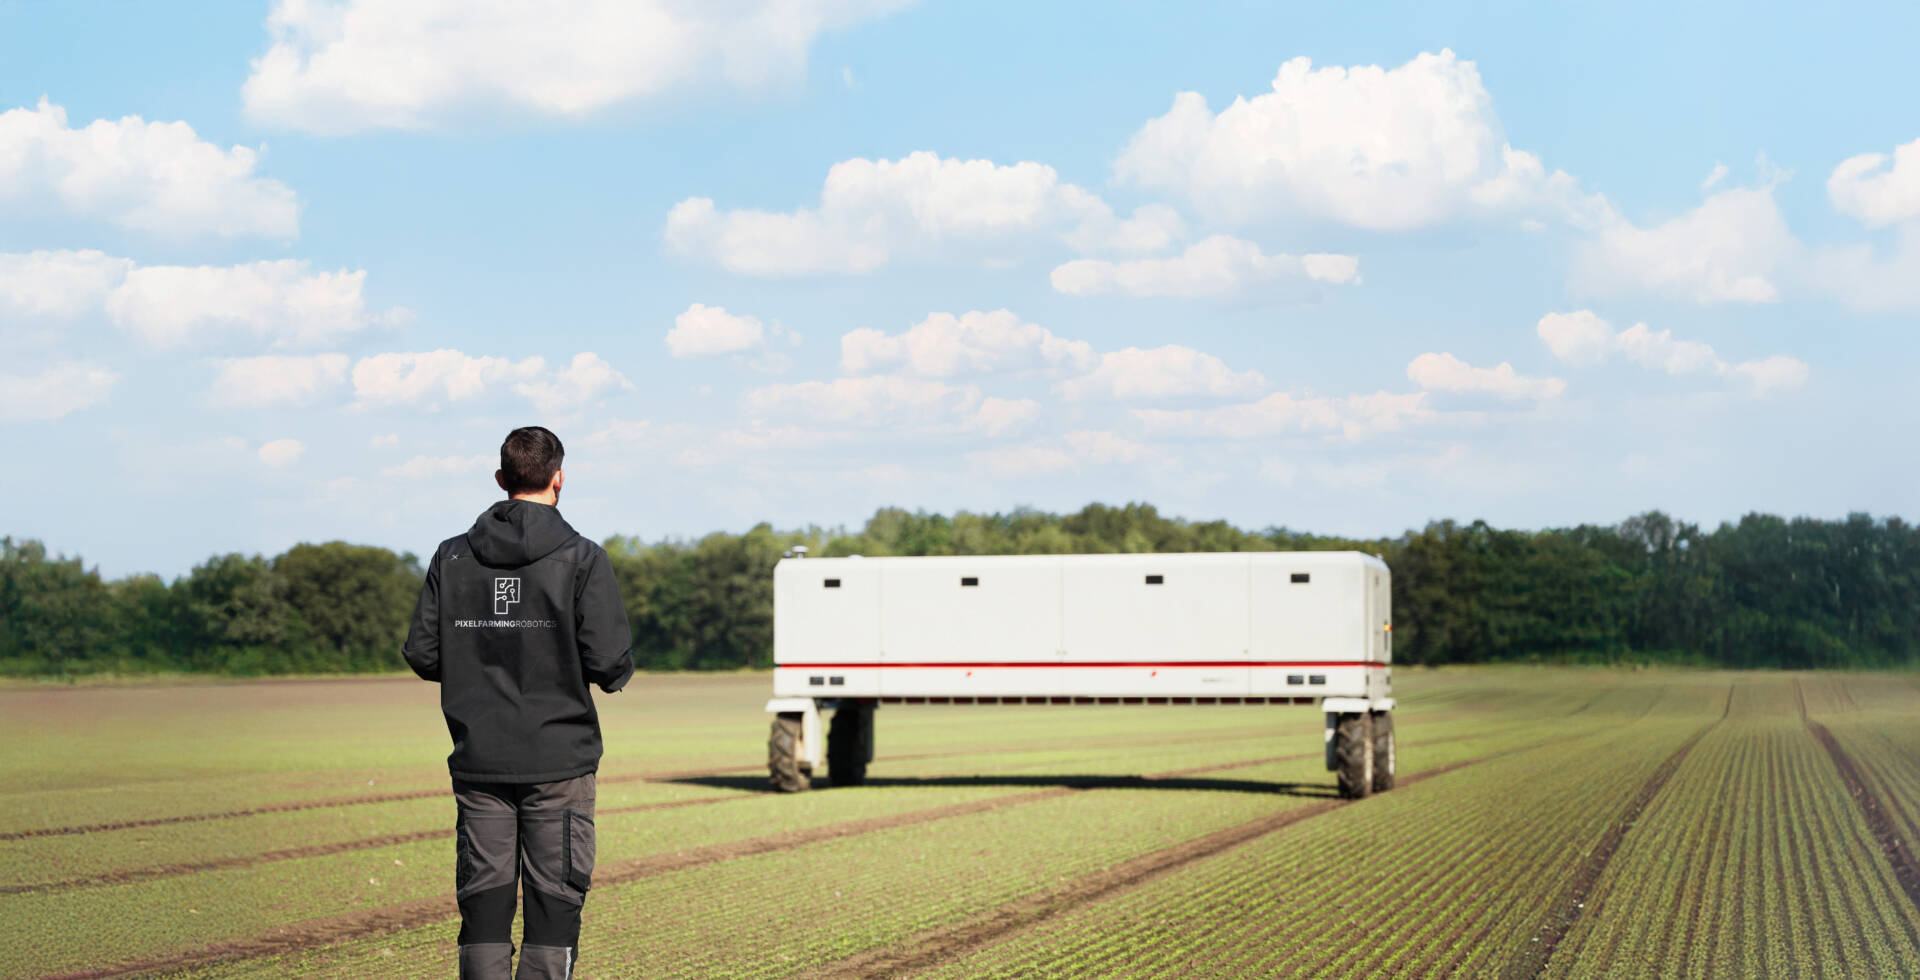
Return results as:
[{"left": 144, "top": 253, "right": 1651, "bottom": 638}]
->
[{"left": 401, "top": 500, "right": 634, "bottom": 782}]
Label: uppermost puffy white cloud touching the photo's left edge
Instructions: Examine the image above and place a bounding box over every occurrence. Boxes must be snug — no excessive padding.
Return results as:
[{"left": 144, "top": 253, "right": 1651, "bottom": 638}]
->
[{"left": 0, "top": 98, "right": 300, "bottom": 238}]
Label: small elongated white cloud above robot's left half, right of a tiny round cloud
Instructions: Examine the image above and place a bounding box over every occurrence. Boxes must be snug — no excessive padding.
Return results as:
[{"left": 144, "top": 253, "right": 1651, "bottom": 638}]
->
[{"left": 841, "top": 309, "right": 1098, "bottom": 379}]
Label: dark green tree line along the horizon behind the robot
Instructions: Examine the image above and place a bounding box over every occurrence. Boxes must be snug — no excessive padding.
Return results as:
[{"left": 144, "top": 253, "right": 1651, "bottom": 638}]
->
[{"left": 0, "top": 503, "right": 1920, "bottom": 676}]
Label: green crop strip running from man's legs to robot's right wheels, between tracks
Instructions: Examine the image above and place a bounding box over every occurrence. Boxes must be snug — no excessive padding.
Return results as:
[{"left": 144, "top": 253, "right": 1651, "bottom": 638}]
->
[{"left": 180, "top": 763, "right": 1336, "bottom": 976}]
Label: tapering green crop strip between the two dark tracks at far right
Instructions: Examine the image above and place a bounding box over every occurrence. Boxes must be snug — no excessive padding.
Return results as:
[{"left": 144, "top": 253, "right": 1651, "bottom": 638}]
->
[{"left": 1551, "top": 682, "right": 1920, "bottom": 976}]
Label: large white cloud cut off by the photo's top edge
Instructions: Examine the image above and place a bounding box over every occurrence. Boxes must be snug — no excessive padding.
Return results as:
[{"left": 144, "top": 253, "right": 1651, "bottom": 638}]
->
[{"left": 240, "top": 0, "right": 904, "bottom": 133}]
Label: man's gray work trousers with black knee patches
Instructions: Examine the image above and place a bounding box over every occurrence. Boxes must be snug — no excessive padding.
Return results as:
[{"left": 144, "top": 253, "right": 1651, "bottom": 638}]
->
[{"left": 453, "top": 772, "right": 593, "bottom": 980}]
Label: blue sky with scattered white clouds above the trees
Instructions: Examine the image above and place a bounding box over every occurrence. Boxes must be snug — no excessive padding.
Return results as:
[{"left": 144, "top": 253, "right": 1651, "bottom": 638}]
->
[{"left": 0, "top": 0, "right": 1920, "bottom": 576}]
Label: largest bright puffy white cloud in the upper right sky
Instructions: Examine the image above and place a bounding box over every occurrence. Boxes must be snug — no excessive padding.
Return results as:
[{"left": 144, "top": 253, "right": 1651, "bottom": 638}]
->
[{"left": 1114, "top": 50, "right": 1605, "bottom": 231}]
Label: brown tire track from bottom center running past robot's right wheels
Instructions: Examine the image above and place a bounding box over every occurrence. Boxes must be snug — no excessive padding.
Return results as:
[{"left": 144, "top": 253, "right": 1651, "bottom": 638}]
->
[{"left": 806, "top": 732, "right": 1592, "bottom": 980}]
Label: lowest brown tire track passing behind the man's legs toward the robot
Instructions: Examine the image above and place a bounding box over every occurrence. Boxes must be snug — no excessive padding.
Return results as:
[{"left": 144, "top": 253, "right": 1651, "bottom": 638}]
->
[{"left": 36, "top": 751, "right": 1320, "bottom": 980}]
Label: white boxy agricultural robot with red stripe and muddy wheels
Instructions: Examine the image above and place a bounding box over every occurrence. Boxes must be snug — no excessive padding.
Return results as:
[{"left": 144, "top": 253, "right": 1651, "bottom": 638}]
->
[{"left": 766, "top": 550, "right": 1394, "bottom": 797}]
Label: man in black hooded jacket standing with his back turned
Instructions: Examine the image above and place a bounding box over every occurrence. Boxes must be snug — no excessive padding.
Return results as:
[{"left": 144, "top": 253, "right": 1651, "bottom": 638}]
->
[{"left": 401, "top": 425, "right": 634, "bottom": 980}]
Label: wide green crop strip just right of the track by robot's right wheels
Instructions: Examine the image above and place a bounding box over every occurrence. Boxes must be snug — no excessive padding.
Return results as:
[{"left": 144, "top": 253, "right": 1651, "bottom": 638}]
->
[{"left": 910, "top": 695, "right": 1712, "bottom": 976}]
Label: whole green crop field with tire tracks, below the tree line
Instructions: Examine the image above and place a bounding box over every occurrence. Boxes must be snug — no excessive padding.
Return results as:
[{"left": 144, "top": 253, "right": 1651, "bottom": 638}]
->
[{"left": 0, "top": 669, "right": 1920, "bottom": 978}]
